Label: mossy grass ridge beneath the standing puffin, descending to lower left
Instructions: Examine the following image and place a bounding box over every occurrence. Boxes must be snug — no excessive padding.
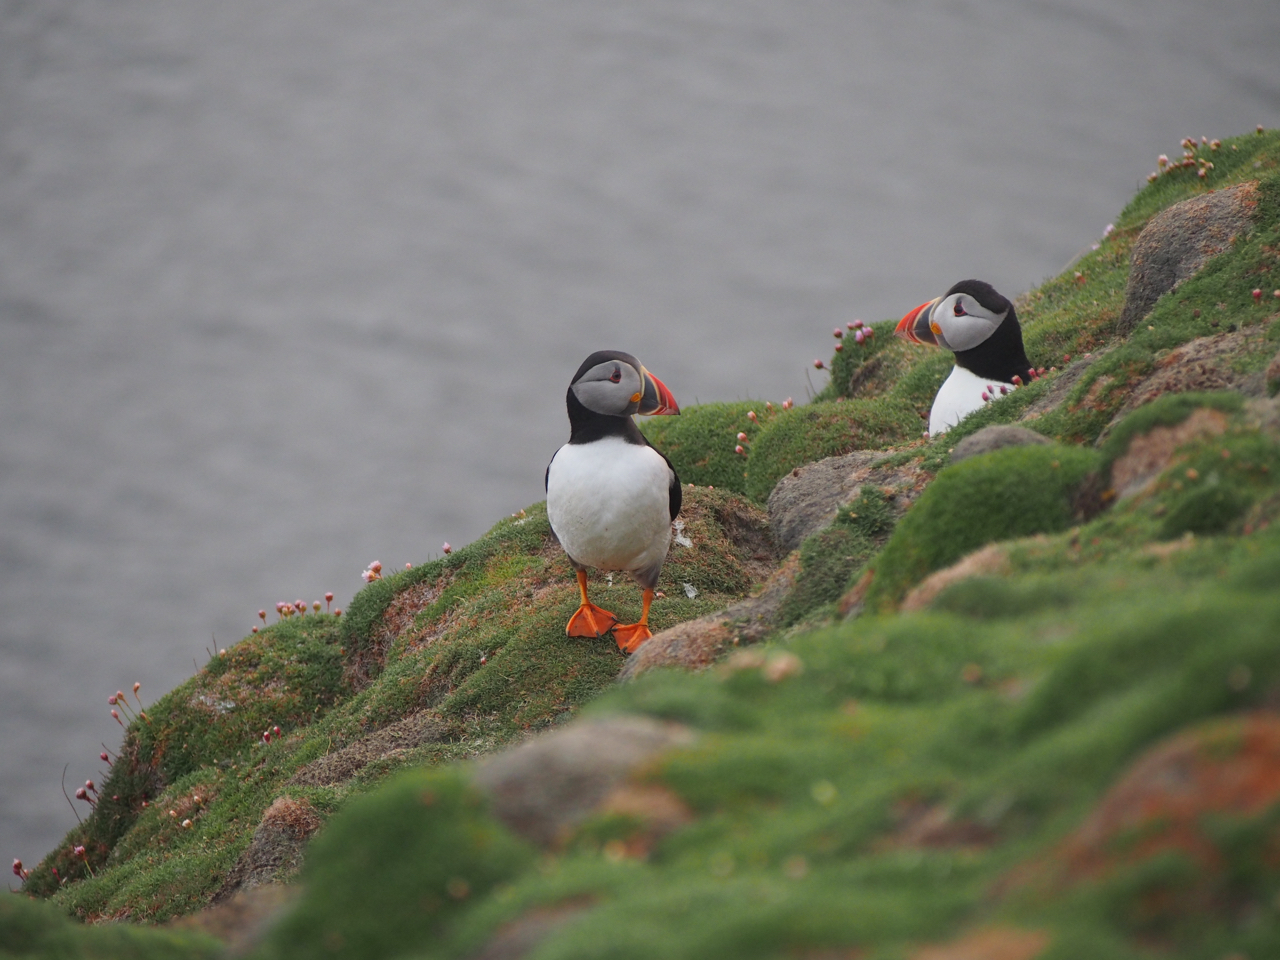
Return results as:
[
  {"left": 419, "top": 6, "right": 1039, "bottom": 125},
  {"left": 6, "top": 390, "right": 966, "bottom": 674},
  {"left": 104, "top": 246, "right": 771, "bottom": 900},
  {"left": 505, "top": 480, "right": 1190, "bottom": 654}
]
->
[{"left": 27, "top": 488, "right": 768, "bottom": 920}]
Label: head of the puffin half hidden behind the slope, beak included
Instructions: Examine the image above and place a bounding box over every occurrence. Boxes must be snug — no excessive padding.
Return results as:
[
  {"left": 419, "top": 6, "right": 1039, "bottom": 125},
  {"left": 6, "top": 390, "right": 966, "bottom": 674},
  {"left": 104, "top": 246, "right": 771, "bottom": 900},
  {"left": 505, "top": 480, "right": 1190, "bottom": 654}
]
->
[{"left": 893, "top": 280, "right": 1030, "bottom": 383}]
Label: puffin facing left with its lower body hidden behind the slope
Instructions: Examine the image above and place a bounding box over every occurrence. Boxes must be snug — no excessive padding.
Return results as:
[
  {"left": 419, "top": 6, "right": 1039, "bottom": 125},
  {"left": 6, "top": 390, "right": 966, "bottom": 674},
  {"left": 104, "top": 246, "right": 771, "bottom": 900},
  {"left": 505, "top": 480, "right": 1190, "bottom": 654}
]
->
[{"left": 893, "top": 280, "right": 1037, "bottom": 436}]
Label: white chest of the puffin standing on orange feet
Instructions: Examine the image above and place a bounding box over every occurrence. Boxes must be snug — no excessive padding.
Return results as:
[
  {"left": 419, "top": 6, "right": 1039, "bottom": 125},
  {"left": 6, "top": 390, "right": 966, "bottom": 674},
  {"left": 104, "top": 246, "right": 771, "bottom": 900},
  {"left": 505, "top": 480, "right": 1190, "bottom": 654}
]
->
[{"left": 547, "top": 438, "right": 672, "bottom": 571}]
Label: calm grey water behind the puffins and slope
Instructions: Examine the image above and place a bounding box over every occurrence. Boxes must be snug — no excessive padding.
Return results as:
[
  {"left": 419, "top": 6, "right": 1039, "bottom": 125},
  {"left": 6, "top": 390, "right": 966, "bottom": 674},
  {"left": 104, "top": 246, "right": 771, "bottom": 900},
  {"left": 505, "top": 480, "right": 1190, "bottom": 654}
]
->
[{"left": 0, "top": 0, "right": 1280, "bottom": 863}]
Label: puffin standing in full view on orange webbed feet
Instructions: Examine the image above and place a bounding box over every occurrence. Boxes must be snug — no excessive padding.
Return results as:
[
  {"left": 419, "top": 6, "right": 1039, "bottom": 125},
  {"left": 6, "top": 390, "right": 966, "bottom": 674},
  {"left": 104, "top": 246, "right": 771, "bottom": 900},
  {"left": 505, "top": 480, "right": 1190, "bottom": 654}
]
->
[{"left": 544, "top": 349, "right": 681, "bottom": 653}]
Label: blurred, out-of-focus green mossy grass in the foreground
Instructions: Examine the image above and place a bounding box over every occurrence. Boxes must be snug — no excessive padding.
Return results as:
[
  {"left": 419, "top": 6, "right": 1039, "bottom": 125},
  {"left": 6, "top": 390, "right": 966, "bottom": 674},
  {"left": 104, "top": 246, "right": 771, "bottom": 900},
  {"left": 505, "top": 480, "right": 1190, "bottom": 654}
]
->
[{"left": 247, "top": 527, "right": 1280, "bottom": 960}]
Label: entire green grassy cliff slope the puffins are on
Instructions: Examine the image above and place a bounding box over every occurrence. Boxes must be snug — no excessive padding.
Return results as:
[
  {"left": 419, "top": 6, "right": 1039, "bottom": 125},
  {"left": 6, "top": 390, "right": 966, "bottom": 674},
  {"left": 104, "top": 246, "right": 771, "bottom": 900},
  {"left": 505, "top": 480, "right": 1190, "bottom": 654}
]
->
[{"left": 10, "top": 132, "right": 1280, "bottom": 960}]
